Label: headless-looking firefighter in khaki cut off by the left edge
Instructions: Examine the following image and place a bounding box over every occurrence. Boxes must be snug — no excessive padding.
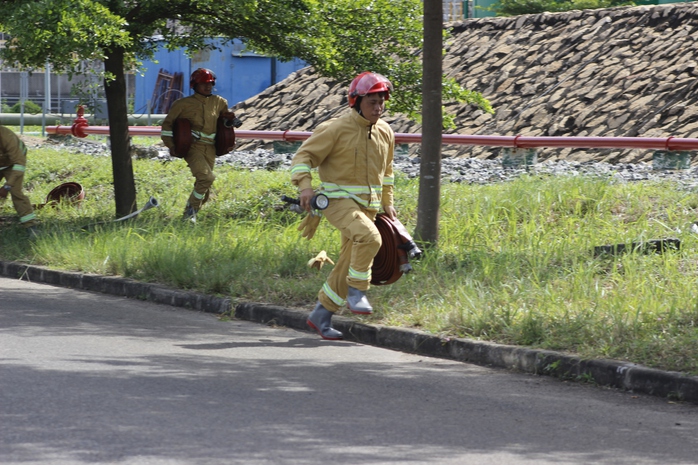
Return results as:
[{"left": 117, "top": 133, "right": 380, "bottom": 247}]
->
[{"left": 0, "top": 126, "right": 36, "bottom": 236}]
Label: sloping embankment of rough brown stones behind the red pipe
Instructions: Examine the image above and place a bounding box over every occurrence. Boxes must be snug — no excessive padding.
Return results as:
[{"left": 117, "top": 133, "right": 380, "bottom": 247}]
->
[{"left": 235, "top": 3, "right": 698, "bottom": 163}]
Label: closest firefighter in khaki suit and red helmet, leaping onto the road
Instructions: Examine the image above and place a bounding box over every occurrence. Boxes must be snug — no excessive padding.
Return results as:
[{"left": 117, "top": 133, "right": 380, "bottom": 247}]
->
[{"left": 291, "top": 72, "right": 396, "bottom": 340}]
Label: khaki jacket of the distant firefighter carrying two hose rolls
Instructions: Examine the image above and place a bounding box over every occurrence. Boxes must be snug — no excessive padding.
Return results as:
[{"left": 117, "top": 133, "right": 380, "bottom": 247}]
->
[{"left": 160, "top": 94, "right": 228, "bottom": 149}]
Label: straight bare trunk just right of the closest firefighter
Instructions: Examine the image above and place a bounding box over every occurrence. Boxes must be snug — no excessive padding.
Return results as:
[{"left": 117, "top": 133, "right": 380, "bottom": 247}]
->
[{"left": 414, "top": 0, "right": 443, "bottom": 245}]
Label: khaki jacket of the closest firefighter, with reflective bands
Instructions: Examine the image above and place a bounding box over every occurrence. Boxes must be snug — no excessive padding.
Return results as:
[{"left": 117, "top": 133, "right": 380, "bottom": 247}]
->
[{"left": 291, "top": 109, "right": 395, "bottom": 211}]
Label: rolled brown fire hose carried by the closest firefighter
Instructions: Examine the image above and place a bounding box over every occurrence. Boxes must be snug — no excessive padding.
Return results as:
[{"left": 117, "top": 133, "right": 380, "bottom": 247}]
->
[{"left": 371, "top": 213, "right": 422, "bottom": 286}]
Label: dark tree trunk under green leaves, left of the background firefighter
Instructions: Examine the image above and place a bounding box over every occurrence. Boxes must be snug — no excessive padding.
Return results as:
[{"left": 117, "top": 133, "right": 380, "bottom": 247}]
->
[{"left": 104, "top": 49, "right": 138, "bottom": 218}]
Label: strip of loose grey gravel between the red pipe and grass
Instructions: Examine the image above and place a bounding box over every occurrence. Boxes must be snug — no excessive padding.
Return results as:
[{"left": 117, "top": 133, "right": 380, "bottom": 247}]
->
[{"left": 42, "top": 138, "right": 698, "bottom": 189}]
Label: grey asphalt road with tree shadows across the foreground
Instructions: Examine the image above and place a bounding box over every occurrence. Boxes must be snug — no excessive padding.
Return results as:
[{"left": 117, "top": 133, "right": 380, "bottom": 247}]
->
[{"left": 0, "top": 277, "right": 698, "bottom": 465}]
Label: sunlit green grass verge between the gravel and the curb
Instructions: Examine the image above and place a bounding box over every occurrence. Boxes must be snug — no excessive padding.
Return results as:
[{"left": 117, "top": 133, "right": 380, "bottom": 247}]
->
[{"left": 0, "top": 145, "right": 698, "bottom": 373}]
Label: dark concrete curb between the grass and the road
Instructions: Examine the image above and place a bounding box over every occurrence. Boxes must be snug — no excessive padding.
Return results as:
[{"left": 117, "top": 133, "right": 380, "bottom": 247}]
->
[{"left": 5, "top": 261, "right": 698, "bottom": 404}]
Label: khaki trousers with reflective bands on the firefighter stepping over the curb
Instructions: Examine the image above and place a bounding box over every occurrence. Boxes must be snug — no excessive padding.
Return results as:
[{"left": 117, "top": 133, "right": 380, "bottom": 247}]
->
[{"left": 318, "top": 199, "right": 382, "bottom": 312}]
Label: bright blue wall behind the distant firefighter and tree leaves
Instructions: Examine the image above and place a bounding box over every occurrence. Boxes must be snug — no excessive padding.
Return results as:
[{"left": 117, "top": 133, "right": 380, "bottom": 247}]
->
[{"left": 133, "top": 40, "right": 306, "bottom": 113}]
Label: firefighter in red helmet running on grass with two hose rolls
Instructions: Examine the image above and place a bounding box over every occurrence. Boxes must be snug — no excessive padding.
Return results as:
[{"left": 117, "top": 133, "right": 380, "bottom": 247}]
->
[{"left": 161, "top": 68, "right": 235, "bottom": 223}]
